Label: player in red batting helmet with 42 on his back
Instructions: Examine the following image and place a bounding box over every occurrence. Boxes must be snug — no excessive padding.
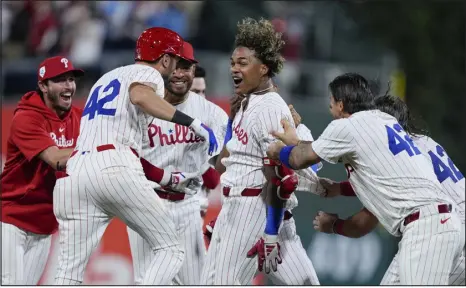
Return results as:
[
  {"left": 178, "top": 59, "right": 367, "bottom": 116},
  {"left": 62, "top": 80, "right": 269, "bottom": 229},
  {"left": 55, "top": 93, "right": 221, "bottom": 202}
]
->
[{"left": 54, "top": 27, "right": 217, "bottom": 285}]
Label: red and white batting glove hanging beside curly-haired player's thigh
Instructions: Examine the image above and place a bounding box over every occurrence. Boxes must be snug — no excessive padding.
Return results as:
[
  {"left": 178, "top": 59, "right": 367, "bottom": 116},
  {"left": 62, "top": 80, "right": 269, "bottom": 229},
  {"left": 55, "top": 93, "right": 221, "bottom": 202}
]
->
[{"left": 247, "top": 234, "right": 282, "bottom": 274}]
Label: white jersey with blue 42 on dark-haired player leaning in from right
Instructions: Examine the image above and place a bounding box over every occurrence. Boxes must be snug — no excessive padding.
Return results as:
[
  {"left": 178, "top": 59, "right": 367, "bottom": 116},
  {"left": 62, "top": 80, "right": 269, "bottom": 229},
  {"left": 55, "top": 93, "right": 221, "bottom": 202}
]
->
[{"left": 312, "top": 110, "right": 450, "bottom": 236}]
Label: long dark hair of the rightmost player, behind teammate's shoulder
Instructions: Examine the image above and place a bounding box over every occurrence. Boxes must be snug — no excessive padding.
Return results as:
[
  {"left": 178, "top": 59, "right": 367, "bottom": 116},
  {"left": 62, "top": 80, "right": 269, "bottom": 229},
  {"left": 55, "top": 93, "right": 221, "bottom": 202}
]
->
[{"left": 374, "top": 87, "right": 429, "bottom": 136}]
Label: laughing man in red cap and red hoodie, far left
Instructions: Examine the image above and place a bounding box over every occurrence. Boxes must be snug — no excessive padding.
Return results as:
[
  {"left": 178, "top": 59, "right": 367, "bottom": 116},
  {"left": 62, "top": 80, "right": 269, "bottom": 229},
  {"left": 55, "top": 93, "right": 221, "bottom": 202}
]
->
[{"left": 1, "top": 56, "right": 84, "bottom": 285}]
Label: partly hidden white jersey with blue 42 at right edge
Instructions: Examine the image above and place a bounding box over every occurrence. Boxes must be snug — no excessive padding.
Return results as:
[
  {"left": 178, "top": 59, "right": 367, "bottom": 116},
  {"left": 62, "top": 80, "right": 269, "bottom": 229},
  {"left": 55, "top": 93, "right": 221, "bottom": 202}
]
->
[{"left": 413, "top": 135, "right": 465, "bottom": 224}]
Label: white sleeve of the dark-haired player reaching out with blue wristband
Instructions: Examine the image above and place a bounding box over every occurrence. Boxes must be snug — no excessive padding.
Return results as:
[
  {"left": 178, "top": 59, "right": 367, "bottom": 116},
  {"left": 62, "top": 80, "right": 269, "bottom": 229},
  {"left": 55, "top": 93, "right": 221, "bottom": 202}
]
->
[{"left": 311, "top": 119, "right": 356, "bottom": 164}]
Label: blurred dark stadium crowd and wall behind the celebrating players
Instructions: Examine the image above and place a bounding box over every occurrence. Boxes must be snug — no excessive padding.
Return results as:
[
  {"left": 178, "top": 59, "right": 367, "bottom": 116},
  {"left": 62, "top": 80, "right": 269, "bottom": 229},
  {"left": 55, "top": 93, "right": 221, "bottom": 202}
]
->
[{"left": 0, "top": 0, "right": 466, "bottom": 285}]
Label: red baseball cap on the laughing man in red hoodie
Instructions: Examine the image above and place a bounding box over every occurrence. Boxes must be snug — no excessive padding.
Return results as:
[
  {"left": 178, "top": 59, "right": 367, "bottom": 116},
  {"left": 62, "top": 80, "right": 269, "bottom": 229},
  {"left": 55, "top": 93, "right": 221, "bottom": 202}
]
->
[{"left": 37, "top": 56, "right": 84, "bottom": 81}]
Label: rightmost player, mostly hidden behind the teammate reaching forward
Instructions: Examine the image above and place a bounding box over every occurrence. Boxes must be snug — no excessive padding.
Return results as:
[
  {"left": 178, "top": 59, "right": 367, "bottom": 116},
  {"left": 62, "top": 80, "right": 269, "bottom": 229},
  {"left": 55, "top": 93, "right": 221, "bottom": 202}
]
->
[{"left": 314, "top": 95, "right": 465, "bottom": 286}]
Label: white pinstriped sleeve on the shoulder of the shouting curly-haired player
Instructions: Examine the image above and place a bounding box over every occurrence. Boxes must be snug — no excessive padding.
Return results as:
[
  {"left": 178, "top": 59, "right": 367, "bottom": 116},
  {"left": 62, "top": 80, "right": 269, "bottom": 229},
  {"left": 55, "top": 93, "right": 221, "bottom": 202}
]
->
[{"left": 253, "top": 105, "right": 294, "bottom": 157}]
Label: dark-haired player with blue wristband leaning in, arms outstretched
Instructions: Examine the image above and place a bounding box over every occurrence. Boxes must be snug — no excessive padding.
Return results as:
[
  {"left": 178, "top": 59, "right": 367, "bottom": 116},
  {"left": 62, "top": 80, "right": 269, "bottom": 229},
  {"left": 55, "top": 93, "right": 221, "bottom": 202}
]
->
[{"left": 267, "top": 73, "right": 464, "bottom": 285}]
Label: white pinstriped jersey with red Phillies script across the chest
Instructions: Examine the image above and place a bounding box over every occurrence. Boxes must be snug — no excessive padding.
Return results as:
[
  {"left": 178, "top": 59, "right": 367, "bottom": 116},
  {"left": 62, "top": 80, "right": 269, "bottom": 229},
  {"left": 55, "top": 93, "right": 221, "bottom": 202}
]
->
[{"left": 142, "top": 91, "right": 228, "bottom": 187}]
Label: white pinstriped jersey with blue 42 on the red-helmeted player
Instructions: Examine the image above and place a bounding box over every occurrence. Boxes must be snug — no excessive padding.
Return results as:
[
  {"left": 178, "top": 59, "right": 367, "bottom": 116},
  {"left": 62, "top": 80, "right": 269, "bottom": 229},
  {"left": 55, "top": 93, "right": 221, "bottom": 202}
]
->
[{"left": 67, "top": 64, "right": 165, "bottom": 171}]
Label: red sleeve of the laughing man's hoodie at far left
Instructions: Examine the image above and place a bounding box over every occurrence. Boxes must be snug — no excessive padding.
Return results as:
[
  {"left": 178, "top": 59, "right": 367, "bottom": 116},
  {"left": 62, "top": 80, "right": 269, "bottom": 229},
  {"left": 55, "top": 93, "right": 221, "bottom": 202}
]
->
[{"left": 10, "top": 111, "right": 56, "bottom": 161}]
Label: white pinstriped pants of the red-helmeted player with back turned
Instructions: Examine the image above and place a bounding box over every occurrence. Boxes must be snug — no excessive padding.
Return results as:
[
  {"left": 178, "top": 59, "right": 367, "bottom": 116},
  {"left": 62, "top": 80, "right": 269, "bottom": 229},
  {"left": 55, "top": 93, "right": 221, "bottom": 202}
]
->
[{"left": 53, "top": 150, "right": 184, "bottom": 285}]
